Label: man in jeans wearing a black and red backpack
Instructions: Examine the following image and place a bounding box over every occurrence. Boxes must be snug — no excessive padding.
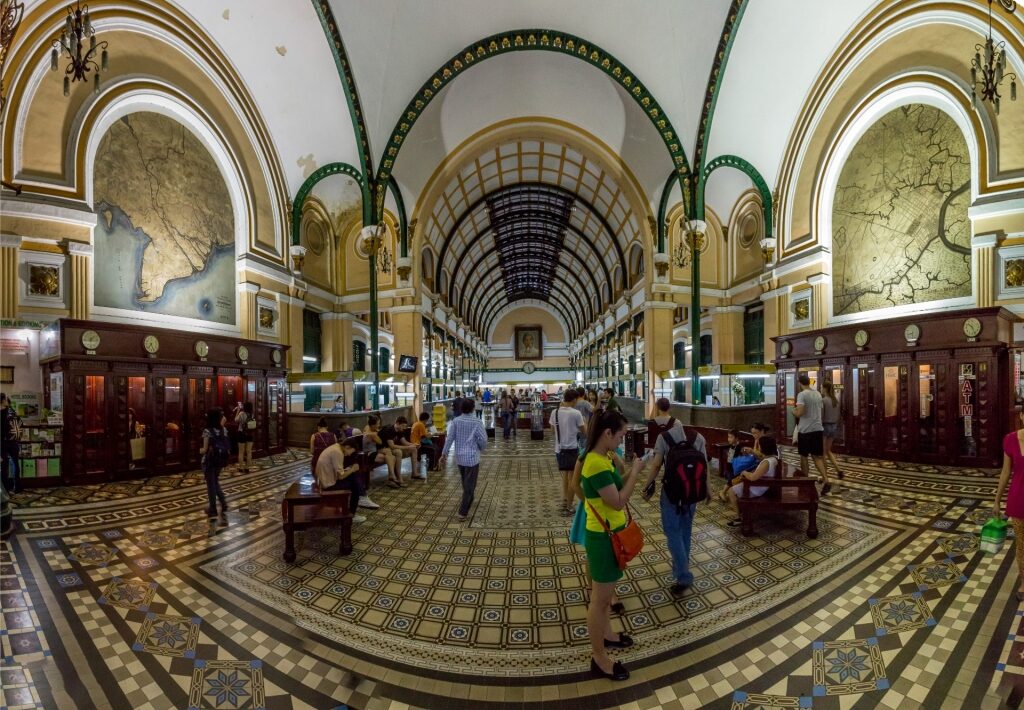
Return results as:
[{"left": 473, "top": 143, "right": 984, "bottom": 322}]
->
[{"left": 643, "top": 407, "right": 709, "bottom": 596}]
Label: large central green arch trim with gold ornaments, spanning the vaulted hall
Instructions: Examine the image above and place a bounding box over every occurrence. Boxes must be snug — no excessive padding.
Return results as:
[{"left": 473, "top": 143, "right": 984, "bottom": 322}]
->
[{"left": 372, "top": 29, "right": 690, "bottom": 219}]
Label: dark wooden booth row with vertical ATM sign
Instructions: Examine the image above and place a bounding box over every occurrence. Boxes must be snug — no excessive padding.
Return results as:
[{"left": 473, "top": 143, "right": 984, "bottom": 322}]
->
[{"left": 774, "top": 308, "right": 1017, "bottom": 467}]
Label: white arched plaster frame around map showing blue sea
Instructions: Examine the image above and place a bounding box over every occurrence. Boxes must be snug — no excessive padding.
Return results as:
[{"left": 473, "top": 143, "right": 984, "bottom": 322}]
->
[{"left": 84, "top": 88, "right": 253, "bottom": 335}]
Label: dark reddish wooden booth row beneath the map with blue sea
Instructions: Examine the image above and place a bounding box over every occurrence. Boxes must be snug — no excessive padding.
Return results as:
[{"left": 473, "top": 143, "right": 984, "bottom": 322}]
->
[{"left": 36, "top": 320, "right": 288, "bottom": 485}]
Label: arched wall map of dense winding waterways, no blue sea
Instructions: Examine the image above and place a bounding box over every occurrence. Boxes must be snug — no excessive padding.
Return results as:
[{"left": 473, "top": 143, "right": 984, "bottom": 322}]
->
[{"left": 833, "top": 105, "right": 971, "bottom": 316}]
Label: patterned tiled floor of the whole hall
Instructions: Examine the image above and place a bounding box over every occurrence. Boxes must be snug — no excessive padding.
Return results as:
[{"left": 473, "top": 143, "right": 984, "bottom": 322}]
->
[{"left": 0, "top": 440, "right": 1024, "bottom": 709}]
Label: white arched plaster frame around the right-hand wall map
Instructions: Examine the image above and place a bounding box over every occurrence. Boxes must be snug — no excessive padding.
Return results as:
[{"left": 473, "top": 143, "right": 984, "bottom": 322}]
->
[{"left": 812, "top": 74, "right": 983, "bottom": 326}]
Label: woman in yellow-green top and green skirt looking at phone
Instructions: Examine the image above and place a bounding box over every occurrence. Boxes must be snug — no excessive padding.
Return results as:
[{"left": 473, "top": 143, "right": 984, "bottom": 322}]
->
[{"left": 580, "top": 411, "right": 642, "bottom": 680}]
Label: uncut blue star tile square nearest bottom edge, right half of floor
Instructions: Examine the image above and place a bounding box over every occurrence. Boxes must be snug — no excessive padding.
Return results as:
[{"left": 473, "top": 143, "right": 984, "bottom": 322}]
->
[{"left": 811, "top": 637, "right": 889, "bottom": 697}]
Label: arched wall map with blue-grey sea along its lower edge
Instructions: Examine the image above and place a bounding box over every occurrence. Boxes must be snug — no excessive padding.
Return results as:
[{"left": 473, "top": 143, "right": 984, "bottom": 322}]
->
[{"left": 94, "top": 112, "right": 236, "bottom": 325}]
